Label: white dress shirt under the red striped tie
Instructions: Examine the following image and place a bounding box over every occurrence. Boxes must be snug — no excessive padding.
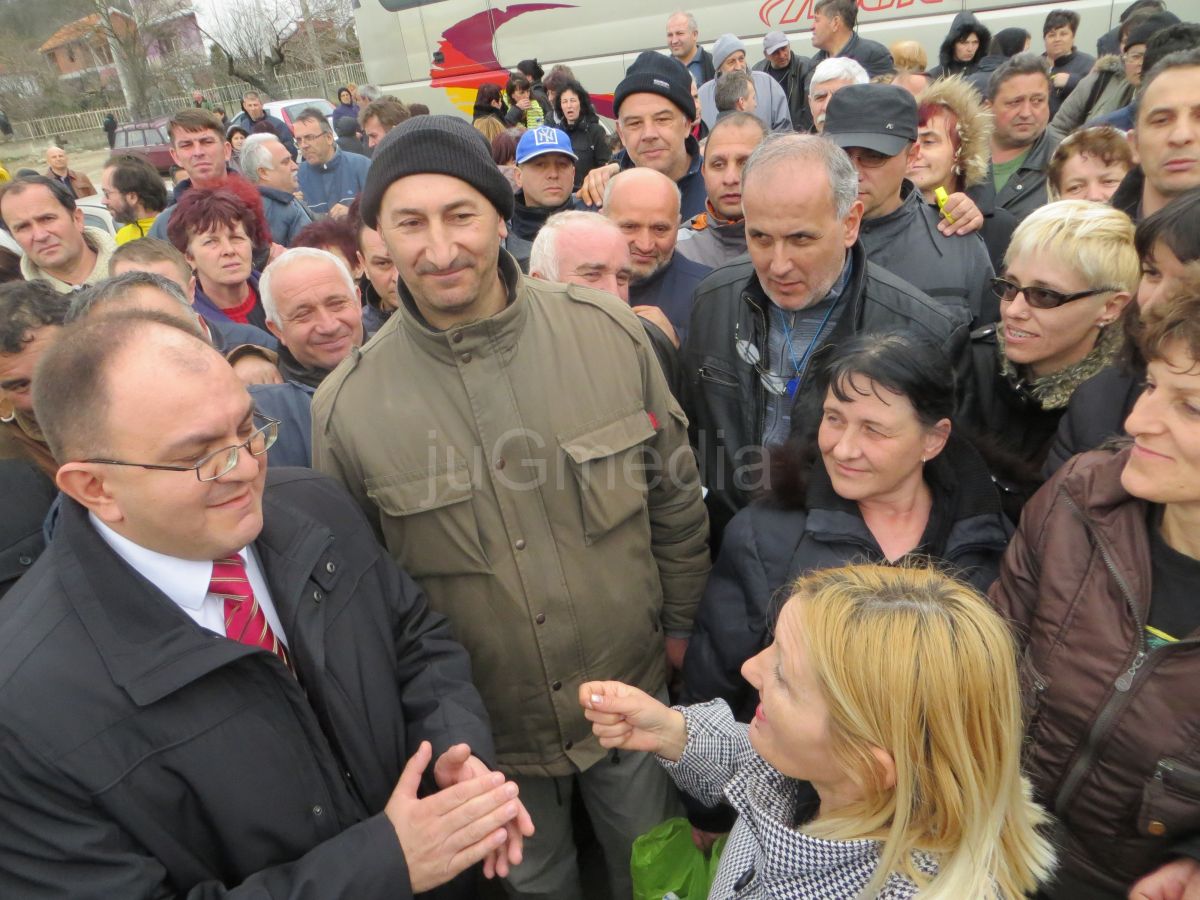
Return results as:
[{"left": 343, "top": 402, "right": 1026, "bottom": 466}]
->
[{"left": 88, "top": 512, "right": 288, "bottom": 647}]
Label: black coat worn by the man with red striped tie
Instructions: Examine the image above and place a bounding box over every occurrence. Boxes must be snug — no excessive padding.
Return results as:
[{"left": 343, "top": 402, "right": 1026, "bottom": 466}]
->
[{"left": 0, "top": 469, "right": 492, "bottom": 898}]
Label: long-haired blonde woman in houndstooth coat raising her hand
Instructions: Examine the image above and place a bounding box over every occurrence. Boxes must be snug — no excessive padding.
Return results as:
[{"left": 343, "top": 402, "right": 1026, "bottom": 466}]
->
[{"left": 580, "top": 565, "right": 1054, "bottom": 900}]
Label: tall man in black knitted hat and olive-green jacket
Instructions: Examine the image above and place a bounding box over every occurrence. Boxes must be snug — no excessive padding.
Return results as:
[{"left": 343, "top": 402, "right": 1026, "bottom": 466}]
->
[{"left": 313, "top": 114, "right": 709, "bottom": 899}]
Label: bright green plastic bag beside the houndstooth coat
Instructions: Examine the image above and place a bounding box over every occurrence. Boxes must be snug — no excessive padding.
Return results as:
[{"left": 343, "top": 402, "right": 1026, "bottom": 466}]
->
[{"left": 629, "top": 818, "right": 726, "bottom": 900}]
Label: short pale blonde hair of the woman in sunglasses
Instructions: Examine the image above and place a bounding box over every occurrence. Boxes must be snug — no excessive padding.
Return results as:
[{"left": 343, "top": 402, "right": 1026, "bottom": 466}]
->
[{"left": 1004, "top": 200, "right": 1141, "bottom": 294}]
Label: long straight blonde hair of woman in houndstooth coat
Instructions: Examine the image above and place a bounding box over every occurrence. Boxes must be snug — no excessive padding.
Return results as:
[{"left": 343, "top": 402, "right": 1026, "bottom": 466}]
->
[{"left": 779, "top": 565, "right": 1054, "bottom": 900}]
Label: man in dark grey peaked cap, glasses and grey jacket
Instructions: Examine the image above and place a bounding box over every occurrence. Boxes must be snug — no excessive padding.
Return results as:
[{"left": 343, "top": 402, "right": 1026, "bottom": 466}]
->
[{"left": 824, "top": 84, "right": 1000, "bottom": 326}]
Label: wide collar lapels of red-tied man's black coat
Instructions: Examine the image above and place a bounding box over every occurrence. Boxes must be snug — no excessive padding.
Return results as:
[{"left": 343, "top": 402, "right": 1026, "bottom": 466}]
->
[{"left": 47, "top": 476, "right": 336, "bottom": 706}]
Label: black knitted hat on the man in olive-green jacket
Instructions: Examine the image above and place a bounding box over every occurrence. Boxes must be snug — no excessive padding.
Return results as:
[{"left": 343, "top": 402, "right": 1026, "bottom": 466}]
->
[{"left": 352, "top": 115, "right": 512, "bottom": 228}]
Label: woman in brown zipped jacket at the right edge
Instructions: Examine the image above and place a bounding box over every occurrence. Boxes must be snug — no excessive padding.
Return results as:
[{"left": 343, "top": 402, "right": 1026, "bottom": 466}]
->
[{"left": 989, "top": 288, "right": 1200, "bottom": 900}]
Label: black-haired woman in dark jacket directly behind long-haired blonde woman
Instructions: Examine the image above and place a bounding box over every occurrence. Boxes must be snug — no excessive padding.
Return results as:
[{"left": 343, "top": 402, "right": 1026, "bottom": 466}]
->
[{"left": 684, "top": 332, "right": 1012, "bottom": 721}]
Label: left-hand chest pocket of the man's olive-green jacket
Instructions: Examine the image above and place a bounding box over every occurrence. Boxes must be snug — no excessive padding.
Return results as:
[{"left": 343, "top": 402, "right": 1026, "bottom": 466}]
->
[{"left": 366, "top": 467, "right": 492, "bottom": 578}]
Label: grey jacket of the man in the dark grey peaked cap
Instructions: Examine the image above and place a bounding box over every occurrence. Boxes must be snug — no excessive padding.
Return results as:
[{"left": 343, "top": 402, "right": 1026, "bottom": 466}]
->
[{"left": 858, "top": 181, "right": 1000, "bottom": 326}]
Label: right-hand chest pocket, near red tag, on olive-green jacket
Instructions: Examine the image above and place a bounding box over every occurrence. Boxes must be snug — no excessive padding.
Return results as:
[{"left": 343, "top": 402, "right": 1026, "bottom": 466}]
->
[{"left": 558, "top": 409, "right": 670, "bottom": 545}]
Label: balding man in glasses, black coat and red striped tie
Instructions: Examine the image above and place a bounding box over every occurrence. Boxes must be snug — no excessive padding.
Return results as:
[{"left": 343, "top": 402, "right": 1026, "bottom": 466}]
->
[{"left": 0, "top": 313, "right": 532, "bottom": 899}]
